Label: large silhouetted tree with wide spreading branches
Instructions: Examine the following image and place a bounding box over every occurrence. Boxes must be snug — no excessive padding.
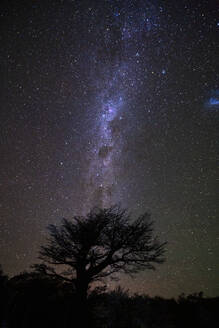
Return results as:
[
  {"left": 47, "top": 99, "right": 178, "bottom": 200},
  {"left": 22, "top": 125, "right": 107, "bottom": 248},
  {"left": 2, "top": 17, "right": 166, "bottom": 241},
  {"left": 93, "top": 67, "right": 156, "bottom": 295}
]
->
[{"left": 34, "top": 206, "right": 165, "bottom": 303}]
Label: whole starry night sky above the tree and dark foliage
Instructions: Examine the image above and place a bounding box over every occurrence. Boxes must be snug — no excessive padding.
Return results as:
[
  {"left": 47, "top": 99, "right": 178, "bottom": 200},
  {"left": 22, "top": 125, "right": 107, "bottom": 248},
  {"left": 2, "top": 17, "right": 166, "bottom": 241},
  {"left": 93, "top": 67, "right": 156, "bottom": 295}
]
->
[{"left": 0, "top": 0, "right": 219, "bottom": 297}]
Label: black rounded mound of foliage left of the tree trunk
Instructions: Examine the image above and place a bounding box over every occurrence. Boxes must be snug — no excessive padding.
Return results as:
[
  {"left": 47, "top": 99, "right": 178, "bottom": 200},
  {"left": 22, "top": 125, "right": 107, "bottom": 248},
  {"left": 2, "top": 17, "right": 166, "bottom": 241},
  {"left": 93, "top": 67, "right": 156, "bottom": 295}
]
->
[{"left": 8, "top": 273, "right": 76, "bottom": 328}]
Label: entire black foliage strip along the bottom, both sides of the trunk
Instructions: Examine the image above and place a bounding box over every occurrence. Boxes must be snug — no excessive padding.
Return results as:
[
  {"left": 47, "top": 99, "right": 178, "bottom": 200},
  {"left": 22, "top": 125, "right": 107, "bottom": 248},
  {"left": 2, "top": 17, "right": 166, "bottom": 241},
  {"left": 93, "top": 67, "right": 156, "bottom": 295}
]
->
[{"left": 2, "top": 273, "right": 219, "bottom": 328}]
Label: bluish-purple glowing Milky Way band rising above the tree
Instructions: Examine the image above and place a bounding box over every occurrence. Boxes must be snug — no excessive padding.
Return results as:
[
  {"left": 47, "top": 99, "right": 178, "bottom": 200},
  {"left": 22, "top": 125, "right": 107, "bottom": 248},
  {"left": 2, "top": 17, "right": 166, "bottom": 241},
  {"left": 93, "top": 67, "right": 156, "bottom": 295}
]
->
[{"left": 82, "top": 1, "right": 161, "bottom": 209}]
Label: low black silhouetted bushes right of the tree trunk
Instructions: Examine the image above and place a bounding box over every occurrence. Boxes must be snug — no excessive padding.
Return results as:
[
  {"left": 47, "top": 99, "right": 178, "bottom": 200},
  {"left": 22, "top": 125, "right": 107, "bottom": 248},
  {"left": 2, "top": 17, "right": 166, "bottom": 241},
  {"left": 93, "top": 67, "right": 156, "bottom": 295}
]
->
[{"left": 90, "top": 288, "right": 219, "bottom": 328}]
